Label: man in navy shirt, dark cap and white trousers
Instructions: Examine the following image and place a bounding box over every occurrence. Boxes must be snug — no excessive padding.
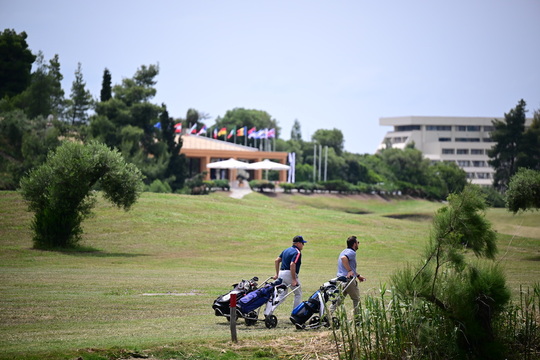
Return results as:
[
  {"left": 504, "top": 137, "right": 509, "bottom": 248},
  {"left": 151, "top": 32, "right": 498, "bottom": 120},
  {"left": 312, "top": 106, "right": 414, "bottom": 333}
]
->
[{"left": 274, "top": 235, "right": 307, "bottom": 309}]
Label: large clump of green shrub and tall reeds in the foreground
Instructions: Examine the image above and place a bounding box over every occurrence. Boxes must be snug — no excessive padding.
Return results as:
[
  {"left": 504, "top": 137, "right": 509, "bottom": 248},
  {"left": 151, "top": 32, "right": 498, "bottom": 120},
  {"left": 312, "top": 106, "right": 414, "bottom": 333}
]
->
[{"left": 330, "top": 186, "right": 540, "bottom": 359}]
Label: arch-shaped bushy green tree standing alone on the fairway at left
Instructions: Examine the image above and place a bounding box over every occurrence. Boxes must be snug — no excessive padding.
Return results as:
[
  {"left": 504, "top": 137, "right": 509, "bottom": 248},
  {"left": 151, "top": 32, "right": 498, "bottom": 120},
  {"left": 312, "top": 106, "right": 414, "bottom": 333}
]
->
[{"left": 21, "top": 142, "right": 143, "bottom": 248}]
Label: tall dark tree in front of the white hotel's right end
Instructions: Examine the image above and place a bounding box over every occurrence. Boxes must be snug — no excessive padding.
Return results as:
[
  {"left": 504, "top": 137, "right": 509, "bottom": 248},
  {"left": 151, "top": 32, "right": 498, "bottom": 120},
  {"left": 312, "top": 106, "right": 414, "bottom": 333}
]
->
[{"left": 488, "top": 99, "right": 527, "bottom": 191}]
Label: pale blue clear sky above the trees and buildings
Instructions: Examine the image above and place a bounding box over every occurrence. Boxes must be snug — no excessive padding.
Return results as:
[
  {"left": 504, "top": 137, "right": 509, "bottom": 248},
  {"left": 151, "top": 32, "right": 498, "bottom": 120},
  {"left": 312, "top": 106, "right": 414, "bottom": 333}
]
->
[{"left": 0, "top": 0, "right": 540, "bottom": 154}]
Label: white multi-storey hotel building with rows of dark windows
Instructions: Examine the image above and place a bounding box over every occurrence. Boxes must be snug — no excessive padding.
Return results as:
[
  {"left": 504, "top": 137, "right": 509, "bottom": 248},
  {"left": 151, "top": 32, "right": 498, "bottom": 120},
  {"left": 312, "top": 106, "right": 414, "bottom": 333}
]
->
[{"left": 377, "top": 116, "right": 532, "bottom": 185}]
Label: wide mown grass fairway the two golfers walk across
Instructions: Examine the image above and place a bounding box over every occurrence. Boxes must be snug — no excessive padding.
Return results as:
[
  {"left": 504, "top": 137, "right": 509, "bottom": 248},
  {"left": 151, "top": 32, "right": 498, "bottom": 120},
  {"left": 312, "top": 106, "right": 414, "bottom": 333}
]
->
[{"left": 0, "top": 192, "right": 540, "bottom": 359}]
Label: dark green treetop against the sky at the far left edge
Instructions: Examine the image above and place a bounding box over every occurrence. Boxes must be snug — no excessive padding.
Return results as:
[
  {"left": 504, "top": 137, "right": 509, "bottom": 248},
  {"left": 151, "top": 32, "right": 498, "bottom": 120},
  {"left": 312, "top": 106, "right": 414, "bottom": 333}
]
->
[{"left": 0, "top": 29, "right": 36, "bottom": 99}]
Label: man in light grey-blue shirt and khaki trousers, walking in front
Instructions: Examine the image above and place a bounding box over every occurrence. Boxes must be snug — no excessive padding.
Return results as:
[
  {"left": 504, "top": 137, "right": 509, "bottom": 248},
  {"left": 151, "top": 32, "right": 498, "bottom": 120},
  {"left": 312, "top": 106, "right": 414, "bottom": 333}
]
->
[{"left": 337, "top": 236, "right": 366, "bottom": 314}]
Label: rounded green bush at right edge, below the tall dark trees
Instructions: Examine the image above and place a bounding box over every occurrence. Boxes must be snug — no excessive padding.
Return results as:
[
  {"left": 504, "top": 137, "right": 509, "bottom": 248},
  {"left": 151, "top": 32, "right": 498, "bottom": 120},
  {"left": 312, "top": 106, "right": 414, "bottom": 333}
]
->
[{"left": 506, "top": 168, "right": 540, "bottom": 214}]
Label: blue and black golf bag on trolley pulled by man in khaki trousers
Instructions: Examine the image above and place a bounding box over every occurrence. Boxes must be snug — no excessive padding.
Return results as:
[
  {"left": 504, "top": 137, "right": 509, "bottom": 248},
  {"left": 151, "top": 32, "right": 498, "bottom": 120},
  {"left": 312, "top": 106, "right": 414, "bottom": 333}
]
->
[{"left": 289, "top": 276, "right": 350, "bottom": 329}]
